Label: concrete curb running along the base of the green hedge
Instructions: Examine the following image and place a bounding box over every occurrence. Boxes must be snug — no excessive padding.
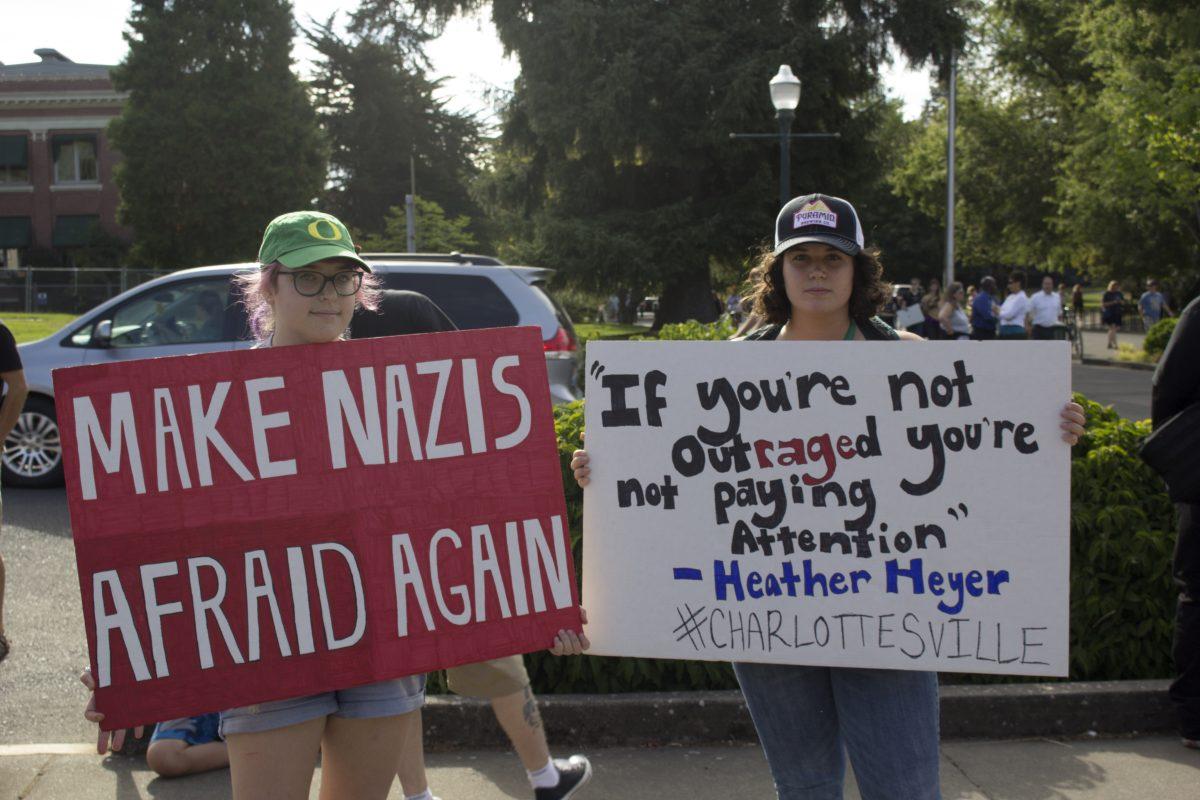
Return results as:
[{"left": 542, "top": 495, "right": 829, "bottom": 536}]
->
[{"left": 424, "top": 680, "right": 1175, "bottom": 752}]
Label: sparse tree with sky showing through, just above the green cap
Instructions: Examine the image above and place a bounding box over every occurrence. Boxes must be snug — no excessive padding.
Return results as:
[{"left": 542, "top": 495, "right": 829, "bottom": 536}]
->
[{"left": 308, "top": 12, "right": 480, "bottom": 241}]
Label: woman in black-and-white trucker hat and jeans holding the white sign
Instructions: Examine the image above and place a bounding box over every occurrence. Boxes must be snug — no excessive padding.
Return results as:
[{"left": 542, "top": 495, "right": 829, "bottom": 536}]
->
[{"left": 571, "top": 194, "right": 1084, "bottom": 800}]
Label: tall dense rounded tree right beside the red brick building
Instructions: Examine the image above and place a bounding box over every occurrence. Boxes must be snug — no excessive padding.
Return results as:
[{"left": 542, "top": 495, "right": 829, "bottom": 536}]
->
[{"left": 109, "top": 0, "right": 325, "bottom": 266}]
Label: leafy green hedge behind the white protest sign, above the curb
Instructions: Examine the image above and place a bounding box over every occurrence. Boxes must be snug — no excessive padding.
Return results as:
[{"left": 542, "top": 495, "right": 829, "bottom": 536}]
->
[{"left": 528, "top": 391, "right": 1177, "bottom": 692}]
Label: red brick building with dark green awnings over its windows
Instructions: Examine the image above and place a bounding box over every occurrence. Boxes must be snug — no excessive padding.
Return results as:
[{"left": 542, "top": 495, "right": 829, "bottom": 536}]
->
[{"left": 0, "top": 49, "right": 130, "bottom": 267}]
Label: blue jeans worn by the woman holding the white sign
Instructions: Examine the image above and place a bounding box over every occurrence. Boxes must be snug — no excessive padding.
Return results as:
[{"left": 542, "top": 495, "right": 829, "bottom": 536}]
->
[{"left": 733, "top": 663, "right": 942, "bottom": 800}]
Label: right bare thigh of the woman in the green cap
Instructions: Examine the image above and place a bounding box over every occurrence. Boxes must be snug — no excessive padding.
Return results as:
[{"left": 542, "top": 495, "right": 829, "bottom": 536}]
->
[{"left": 320, "top": 711, "right": 414, "bottom": 800}]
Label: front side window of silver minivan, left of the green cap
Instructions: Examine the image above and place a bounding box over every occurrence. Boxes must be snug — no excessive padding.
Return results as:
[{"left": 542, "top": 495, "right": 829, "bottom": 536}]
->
[{"left": 109, "top": 276, "right": 229, "bottom": 348}]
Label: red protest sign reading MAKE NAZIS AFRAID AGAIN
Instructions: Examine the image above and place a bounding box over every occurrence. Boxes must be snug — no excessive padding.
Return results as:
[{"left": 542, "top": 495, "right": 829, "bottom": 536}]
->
[{"left": 54, "top": 327, "right": 580, "bottom": 728}]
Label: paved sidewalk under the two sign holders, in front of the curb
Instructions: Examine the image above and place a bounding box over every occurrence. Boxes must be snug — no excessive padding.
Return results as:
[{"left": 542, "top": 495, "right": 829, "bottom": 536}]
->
[{"left": 0, "top": 738, "right": 1200, "bottom": 800}]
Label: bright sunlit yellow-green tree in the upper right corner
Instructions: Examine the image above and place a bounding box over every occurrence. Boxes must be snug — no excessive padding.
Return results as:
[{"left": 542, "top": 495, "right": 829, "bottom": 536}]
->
[{"left": 995, "top": 0, "right": 1200, "bottom": 291}]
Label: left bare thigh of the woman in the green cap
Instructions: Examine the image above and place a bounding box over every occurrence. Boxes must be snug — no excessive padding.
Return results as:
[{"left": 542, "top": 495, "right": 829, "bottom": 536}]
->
[{"left": 226, "top": 717, "right": 324, "bottom": 800}]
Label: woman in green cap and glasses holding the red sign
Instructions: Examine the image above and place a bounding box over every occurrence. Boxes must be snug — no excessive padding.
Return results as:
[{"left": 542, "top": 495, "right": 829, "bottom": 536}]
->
[{"left": 83, "top": 211, "right": 582, "bottom": 800}]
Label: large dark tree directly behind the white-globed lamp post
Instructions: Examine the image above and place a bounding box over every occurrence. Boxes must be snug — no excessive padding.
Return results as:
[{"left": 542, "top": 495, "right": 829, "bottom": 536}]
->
[{"left": 366, "top": 0, "right": 962, "bottom": 323}]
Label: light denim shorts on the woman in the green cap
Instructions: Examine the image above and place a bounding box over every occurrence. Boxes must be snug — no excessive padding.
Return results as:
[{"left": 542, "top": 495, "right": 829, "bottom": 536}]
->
[{"left": 221, "top": 675, "right": 425, "bottom": 736}]
